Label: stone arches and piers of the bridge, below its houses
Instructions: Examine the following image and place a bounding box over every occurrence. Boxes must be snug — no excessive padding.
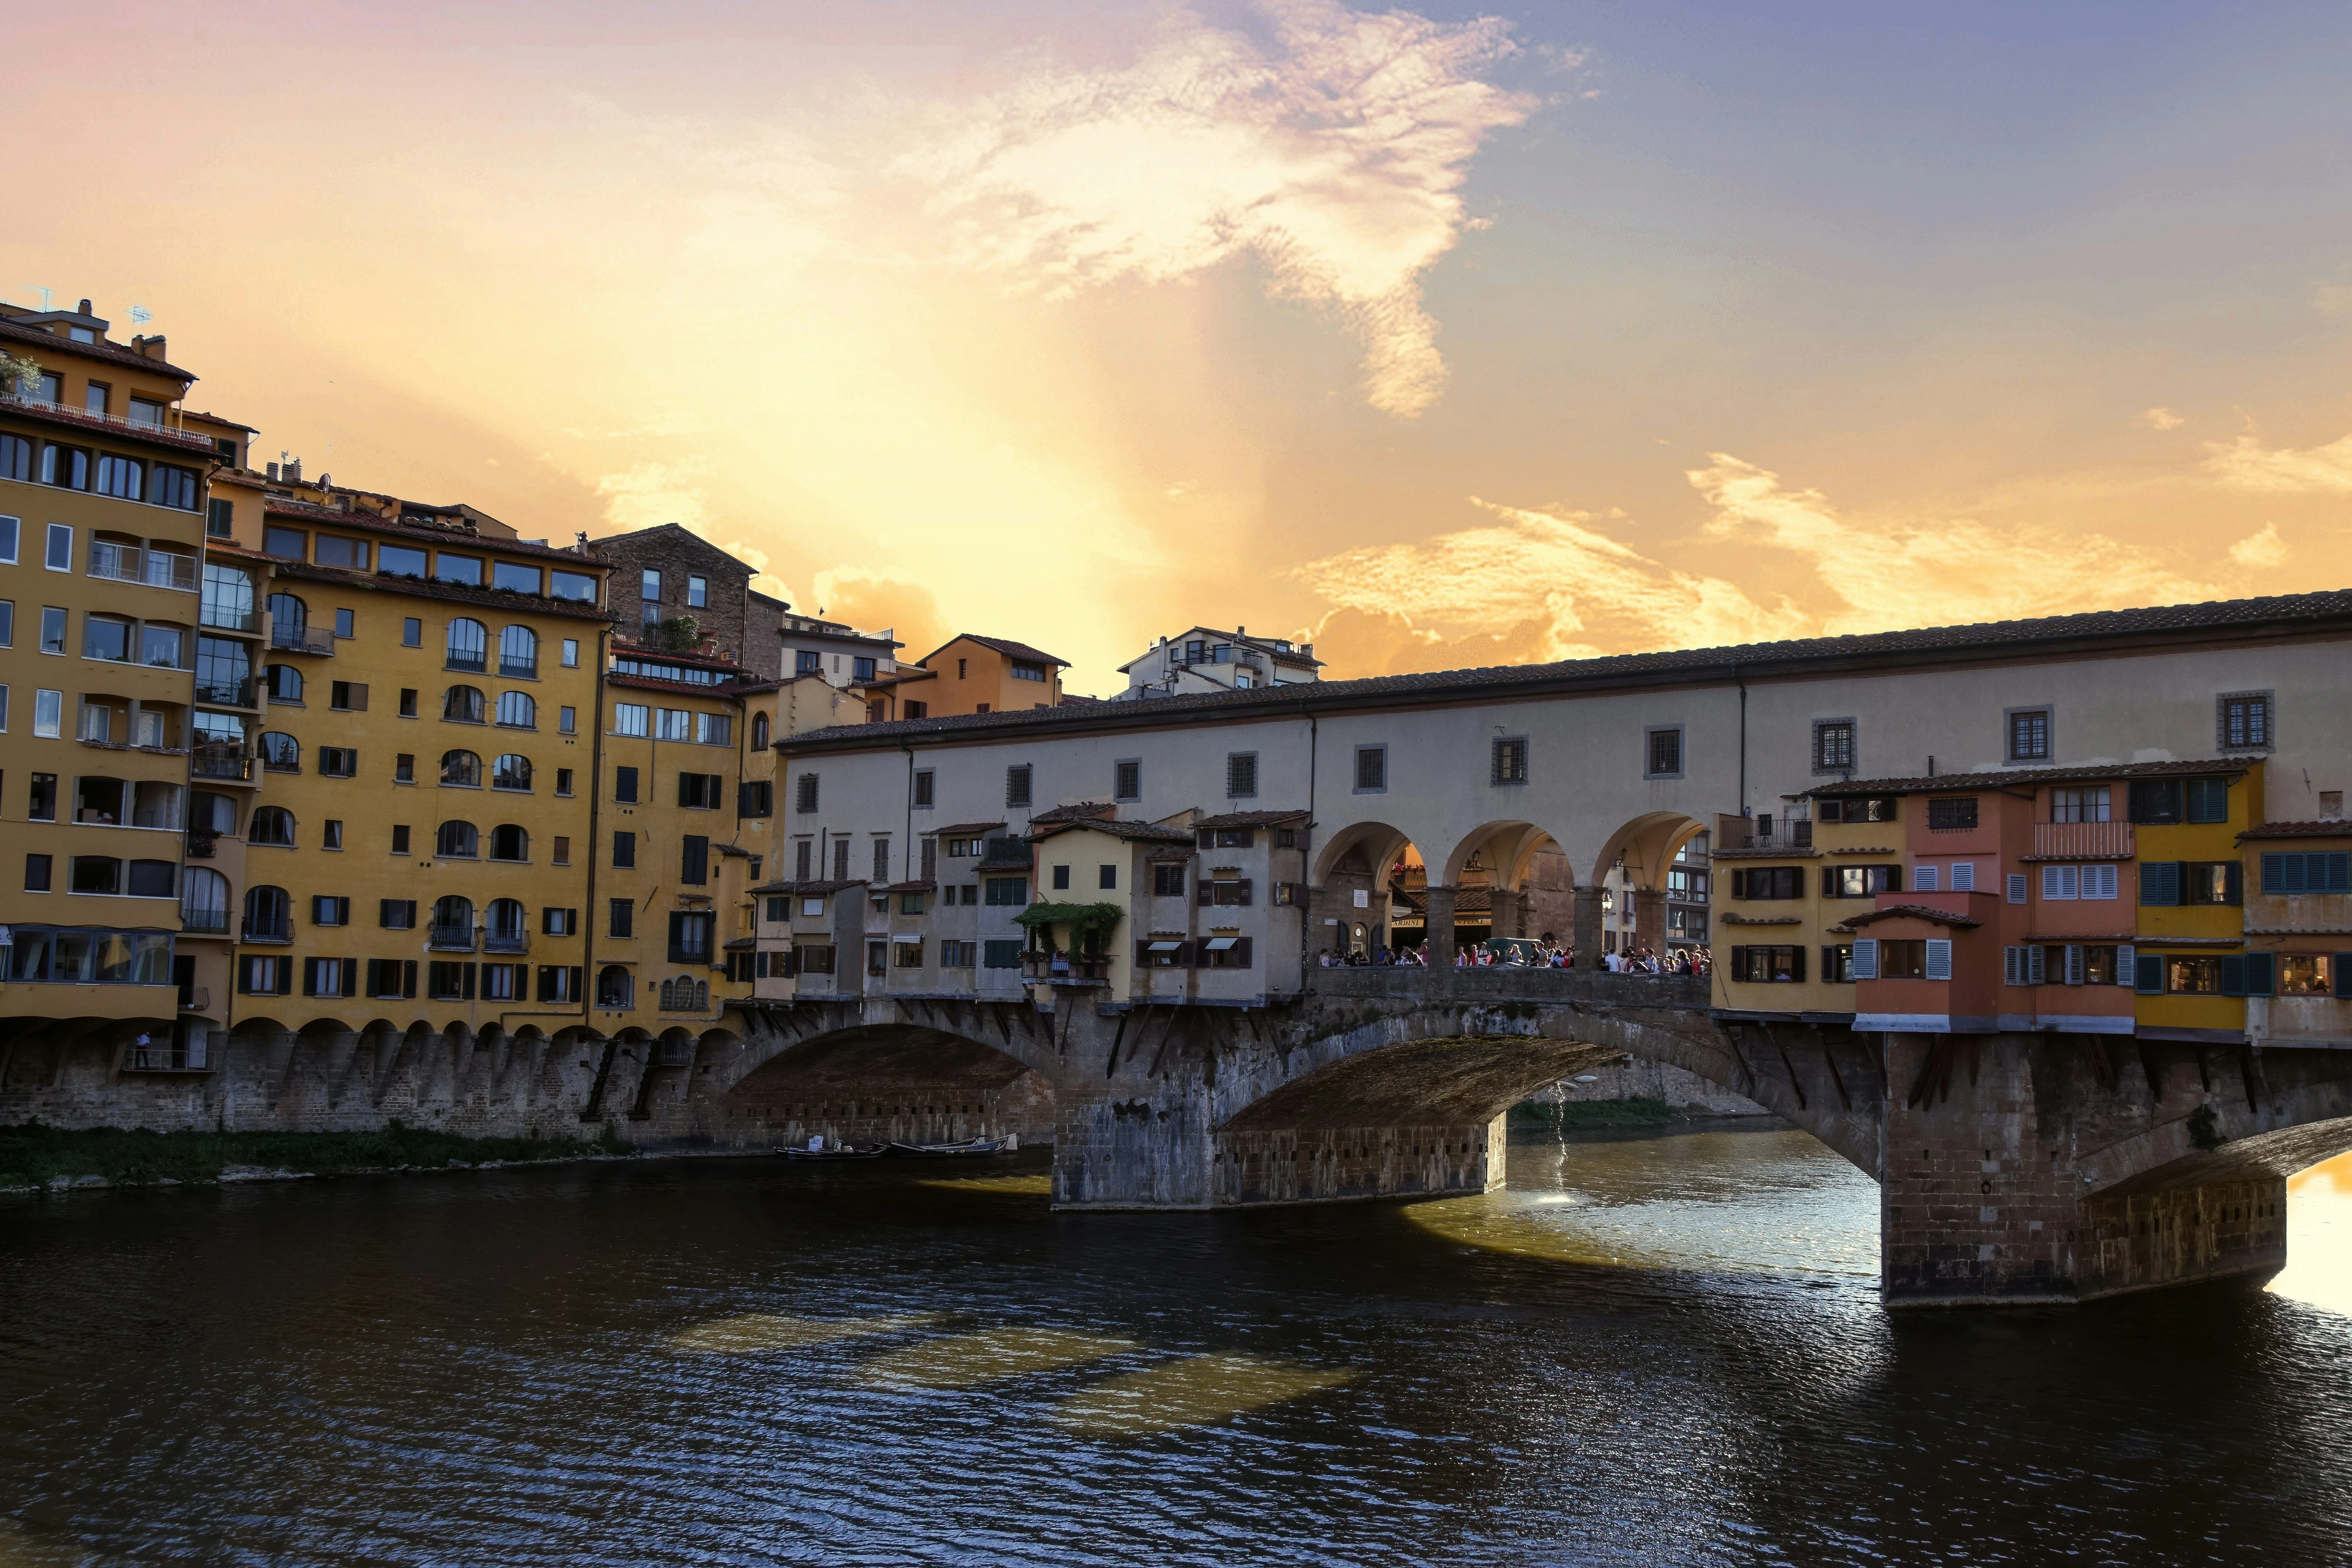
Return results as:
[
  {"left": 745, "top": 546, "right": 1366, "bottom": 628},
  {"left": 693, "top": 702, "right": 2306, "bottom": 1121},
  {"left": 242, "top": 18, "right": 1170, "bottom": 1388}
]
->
[{"left": 663, "top": 969, "right": 2352, "bottom": 1305}]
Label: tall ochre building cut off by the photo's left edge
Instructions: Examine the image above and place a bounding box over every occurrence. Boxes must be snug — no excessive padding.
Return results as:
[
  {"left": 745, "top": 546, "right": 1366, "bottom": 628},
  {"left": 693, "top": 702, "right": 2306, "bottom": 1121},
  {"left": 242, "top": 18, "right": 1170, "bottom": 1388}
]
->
[{"left": 0, "top": 301, "right": 242, "bottom": 1072}]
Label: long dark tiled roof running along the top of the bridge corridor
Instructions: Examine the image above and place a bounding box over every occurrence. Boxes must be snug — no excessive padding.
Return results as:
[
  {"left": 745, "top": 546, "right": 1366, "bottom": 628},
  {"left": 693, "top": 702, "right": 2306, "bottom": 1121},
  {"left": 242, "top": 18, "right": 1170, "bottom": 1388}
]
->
[{"left": 793, "top": 590, "right": 2352, "bottom": 752}]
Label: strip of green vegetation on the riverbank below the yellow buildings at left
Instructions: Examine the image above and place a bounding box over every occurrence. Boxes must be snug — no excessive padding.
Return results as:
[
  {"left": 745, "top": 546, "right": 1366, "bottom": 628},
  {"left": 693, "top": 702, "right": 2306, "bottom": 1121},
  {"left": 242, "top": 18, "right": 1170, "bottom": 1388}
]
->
[{"left": 0, "top": 1122, "right": 633, "bottom": 1189}]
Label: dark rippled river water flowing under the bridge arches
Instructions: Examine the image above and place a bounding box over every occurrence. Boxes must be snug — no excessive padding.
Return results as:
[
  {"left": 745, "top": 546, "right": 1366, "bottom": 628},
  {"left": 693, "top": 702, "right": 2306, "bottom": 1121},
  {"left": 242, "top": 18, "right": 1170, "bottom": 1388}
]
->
[{"left": 0, "top": 1129, "right": 2352, "bottom": 1568}]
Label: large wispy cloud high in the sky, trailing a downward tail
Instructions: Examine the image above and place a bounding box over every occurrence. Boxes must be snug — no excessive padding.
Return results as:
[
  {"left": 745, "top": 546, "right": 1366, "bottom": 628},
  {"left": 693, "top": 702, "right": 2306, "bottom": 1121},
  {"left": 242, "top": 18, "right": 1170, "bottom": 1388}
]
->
[{"left": 898, "top": 0, "right": 1531, "bottom": 416}]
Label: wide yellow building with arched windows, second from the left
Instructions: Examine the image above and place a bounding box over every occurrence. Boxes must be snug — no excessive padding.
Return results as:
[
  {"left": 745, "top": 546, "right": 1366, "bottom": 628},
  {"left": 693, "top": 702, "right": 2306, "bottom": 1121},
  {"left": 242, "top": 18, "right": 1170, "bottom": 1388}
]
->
[{"left": 195, "top": 465, "right": 609, "bottom": 1034}]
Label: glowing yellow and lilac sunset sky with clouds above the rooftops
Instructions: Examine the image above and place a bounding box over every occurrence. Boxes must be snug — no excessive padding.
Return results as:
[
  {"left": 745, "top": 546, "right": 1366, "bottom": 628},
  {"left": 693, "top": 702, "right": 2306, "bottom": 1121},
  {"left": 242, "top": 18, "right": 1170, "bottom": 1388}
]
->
[{"left": 0, "top": 0, "right": 2352, "bottom": 691}]
